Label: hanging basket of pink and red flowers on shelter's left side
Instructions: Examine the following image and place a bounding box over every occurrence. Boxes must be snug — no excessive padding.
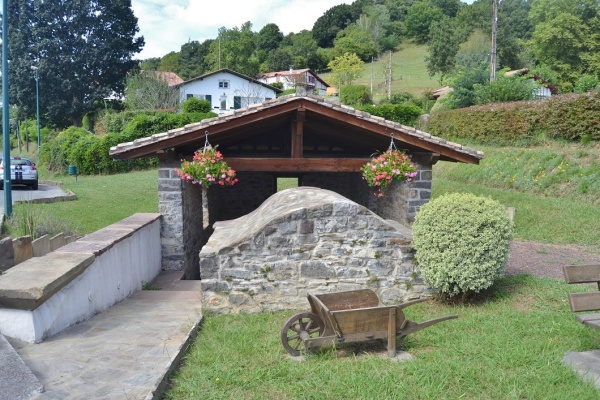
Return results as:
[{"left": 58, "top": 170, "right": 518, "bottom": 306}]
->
[{"left": 177, "top": 145, "right": 238, "bottom": 188}]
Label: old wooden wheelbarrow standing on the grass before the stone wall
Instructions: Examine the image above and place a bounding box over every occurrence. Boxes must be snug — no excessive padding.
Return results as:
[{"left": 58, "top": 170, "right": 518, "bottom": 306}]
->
[{"left": 281, "top": 289, "right": 458, "bottom": 357}]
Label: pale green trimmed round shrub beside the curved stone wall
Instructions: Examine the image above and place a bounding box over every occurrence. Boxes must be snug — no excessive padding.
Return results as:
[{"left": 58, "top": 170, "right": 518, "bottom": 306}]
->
[{"left": 412, "top": 193, "right": 513, "bottom": 296}]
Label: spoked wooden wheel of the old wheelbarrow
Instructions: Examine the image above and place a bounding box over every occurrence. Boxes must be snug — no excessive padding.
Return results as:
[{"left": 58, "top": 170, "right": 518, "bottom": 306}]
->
[{"left": 281, "top": 312, "right": 325, "bottom": 356}]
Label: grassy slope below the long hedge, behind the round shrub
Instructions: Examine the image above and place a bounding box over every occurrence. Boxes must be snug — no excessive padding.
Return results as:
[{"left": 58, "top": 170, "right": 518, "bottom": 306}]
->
[{"left": 432, "top": 143, "right": 600, "bottom": 249}]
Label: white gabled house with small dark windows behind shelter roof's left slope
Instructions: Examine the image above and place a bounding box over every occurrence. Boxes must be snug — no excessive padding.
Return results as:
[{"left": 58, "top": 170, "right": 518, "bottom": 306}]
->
[{"left": 176, "top": 68, "right": 281, "bottom": 114}]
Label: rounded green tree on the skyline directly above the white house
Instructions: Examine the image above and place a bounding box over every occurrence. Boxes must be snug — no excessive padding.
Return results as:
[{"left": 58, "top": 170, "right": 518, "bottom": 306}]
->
[{"left": 206, "top": 21, "right": 260, "bottom": 76}]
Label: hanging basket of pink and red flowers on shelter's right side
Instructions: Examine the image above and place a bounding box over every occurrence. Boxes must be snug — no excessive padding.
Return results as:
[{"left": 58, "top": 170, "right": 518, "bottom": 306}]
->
[{"left": 361, "top": 148, "right": 417, "bottom": 197}]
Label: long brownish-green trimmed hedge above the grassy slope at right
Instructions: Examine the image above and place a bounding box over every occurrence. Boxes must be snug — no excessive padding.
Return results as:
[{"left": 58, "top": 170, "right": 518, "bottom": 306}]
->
[{"left": 421, "top": 90, "right": 600, "bottom": 144}]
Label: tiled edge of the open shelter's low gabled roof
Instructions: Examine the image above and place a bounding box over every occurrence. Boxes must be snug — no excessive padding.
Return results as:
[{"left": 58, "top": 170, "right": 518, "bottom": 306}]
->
[{"left": 109, "top": 94, "right": 483, "bottom": 160}]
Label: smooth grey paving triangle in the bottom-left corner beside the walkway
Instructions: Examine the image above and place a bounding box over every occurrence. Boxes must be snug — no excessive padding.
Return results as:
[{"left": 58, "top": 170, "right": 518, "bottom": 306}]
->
[{"left": 0, "top": 333, "right": 44, "bottom": 399}]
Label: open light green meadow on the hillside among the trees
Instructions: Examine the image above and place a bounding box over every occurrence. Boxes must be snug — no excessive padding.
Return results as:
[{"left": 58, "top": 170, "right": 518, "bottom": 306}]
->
[{"left": 320, "top": 41, "right": 440, "bottom": 101}]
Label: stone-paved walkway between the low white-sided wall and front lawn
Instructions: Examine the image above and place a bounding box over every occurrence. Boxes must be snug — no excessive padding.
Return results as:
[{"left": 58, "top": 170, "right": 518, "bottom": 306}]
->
[{"left": 7, "top": 272, "right": 202, "bottom": 400}]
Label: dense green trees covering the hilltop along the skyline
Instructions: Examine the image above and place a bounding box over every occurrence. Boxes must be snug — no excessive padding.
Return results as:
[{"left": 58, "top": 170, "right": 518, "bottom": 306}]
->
[{"left": 142, "top": 0, "right": 600, "bottom": 96}]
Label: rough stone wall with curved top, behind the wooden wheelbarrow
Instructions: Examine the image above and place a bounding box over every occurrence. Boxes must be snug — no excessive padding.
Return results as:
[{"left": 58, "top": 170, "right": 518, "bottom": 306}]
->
[{"left": 200, "top": 187, "right": 431, "bottom": 312}]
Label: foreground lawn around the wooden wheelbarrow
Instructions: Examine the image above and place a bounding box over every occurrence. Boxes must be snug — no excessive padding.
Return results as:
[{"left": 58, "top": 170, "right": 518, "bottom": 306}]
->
[{"left": 166, "top": 276, "right": 600, "bottom": 399}]
